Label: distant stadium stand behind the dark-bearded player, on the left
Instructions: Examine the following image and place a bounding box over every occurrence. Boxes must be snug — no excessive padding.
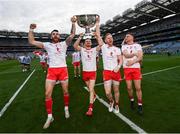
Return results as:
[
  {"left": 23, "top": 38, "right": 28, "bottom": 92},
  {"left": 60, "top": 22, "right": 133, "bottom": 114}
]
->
[{"left": 0, "top": 31, "right": 68, "bottom": 60}]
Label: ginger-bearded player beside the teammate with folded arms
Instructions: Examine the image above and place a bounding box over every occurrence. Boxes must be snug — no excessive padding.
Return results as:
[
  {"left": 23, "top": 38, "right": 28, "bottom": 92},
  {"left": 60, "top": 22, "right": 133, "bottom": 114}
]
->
[{"left": 95, "top": 33, "right": 122, "bottom": 113}]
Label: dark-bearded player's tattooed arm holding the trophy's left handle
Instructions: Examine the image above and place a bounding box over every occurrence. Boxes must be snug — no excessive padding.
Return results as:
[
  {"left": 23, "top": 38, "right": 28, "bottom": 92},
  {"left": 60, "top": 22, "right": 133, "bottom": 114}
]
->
[{"left": 66, "top": 16, "right": 77, "bottom": 45}]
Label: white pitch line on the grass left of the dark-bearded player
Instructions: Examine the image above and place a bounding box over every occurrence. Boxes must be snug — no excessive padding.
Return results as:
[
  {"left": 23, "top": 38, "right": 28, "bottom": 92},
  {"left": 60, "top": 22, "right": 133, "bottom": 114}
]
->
[{"left": 0, "top": 69, "right": 35, "bottom": 117}]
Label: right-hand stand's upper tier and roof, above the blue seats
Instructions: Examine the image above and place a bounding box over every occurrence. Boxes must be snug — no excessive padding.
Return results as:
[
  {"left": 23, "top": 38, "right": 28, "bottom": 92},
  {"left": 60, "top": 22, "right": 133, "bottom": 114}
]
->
[{"left": 101, "top": 0, "right": 180, "bottom": 45}]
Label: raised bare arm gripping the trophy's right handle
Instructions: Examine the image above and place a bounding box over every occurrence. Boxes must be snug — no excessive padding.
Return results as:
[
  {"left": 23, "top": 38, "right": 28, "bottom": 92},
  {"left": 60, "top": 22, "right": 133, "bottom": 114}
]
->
[{"left": 95, "top": 16, "right": 104, "bottom": 51}]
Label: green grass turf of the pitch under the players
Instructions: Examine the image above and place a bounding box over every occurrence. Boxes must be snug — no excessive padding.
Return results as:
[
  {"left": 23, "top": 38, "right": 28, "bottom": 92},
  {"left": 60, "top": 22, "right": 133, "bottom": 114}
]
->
[{"left": 0, "top": 55, "right": 180, "bottom": 133}]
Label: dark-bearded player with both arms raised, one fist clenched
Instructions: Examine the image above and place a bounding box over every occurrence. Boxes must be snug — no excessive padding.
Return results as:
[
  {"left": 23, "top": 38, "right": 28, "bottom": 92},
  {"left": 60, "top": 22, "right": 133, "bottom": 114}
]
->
[{"left": 28, "top": 16, "right": 76, "bottom": 129}]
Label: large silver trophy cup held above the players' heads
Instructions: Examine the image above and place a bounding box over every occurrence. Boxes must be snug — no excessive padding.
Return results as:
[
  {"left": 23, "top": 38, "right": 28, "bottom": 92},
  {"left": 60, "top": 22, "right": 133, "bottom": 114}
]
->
[{"left": 76, "top": 14, "right": 99, "bottom": 39}]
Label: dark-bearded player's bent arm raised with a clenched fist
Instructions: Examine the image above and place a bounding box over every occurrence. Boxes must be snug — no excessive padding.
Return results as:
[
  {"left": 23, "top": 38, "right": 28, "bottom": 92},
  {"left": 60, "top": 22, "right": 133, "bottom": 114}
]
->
[{"left": 28, "top": 24, "right": 43, "bottom": 48}]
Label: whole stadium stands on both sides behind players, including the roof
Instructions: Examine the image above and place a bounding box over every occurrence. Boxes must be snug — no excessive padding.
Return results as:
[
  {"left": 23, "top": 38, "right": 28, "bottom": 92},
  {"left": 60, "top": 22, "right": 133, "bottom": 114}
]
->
[{"left": 0, "top": 0, "right": 180, "bottom": 58}]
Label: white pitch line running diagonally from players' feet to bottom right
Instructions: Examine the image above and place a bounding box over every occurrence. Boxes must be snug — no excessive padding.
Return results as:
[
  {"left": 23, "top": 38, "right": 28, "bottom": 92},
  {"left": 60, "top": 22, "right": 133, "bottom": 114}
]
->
[{"left": 84, "top": 87, "right": 147, "bottom": 134}]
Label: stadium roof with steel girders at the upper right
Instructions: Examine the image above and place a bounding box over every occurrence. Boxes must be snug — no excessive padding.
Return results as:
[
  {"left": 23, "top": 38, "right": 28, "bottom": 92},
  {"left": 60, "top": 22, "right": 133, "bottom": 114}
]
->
[{"left": 100, "top": 0, "right": 180, "bottom": 34}]
